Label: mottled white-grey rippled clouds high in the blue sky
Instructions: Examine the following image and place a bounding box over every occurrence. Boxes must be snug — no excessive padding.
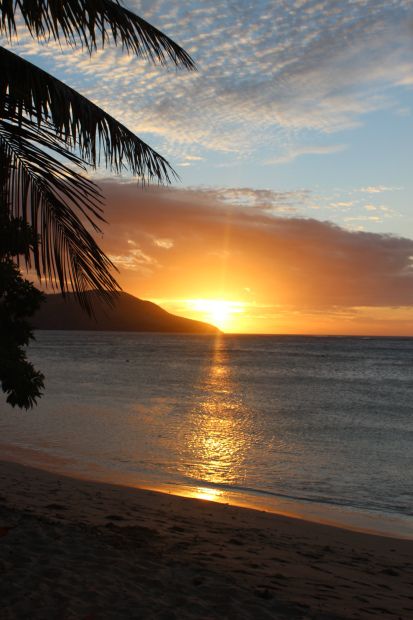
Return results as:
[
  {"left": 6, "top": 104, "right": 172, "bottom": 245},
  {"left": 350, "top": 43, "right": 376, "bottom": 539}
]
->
[{"left": 5, "top": 0, "right": 413, "bottom": 163}]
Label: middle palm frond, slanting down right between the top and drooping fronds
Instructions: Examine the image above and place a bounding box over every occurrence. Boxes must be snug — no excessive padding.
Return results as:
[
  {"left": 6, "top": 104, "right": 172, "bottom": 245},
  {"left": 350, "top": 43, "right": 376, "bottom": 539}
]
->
[{"left": 0, "top": 47, "right": 177, "bottom": 183}]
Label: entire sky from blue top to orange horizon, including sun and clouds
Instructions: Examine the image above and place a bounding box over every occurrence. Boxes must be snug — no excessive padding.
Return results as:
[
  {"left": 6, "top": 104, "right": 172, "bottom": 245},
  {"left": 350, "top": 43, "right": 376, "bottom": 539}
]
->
[{"left": 4, "top": 0, "right": 413, "bottom": 336}]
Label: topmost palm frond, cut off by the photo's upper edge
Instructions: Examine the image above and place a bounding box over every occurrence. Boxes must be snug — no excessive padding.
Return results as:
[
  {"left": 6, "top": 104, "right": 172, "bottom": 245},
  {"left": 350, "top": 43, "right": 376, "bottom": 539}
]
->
[{"left": 0, "top": 0, "right": 195, "bottom": 70}]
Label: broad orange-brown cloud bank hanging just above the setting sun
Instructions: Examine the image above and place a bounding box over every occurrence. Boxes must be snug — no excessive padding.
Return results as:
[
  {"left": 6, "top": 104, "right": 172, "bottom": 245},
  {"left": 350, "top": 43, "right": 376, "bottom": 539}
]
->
[{"left": 97, "top": 182, "right": 413, "bottom": 312}]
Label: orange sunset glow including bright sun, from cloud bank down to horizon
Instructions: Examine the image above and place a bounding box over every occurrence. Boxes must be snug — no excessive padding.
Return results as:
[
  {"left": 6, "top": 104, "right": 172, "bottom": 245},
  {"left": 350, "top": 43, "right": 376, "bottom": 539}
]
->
[{"left": 98, "top": 183, "right": 413, "bottom": 336}]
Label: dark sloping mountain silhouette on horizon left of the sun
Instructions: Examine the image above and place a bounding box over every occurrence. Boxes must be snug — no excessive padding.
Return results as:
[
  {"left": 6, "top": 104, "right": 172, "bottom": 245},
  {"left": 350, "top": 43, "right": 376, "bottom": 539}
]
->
[{"left": 31, "top": 291, "right": 220, "bottom": 334}]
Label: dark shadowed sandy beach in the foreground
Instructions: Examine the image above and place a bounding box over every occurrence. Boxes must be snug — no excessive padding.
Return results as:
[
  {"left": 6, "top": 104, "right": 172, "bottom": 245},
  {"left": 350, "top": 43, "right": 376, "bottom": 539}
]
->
[{"left": 0, "top": 462, "right": 413, "bottom": 620}]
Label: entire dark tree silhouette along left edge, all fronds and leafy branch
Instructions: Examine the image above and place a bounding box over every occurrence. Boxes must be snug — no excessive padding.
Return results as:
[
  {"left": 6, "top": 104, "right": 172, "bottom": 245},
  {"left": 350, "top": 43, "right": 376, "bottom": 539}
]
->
[{"left": 0, "top": 0, "right": 195, "bottom": 409}]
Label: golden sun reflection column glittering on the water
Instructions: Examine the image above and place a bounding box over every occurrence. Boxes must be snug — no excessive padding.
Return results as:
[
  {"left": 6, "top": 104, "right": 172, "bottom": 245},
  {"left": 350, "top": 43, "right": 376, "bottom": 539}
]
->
[{"left": 179, "top": 336, "right": 253, "bottom": 500}]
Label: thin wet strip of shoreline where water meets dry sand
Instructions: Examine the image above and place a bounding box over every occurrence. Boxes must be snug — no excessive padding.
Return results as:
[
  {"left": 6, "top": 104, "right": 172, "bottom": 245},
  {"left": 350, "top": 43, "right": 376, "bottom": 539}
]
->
[{"left": 0, "top": 442, "right": 413, "bottom": 540}]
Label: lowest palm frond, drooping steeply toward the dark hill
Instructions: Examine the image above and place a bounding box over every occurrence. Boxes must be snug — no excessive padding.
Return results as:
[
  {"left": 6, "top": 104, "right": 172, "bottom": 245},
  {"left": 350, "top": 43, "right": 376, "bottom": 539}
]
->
[{"left": 0, "top": 119, "right": 119, "bottom": 312}]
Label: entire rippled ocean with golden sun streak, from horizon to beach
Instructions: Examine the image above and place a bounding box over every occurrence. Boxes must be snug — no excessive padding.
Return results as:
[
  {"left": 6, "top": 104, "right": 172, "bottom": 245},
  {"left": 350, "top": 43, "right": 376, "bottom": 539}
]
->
[{"left": 0, "top": 331, "right": 413, "bottom": 537}]
